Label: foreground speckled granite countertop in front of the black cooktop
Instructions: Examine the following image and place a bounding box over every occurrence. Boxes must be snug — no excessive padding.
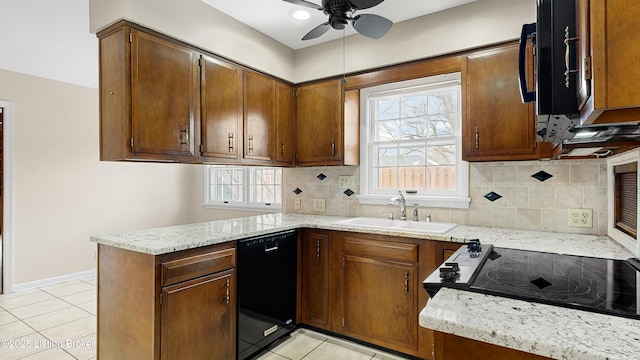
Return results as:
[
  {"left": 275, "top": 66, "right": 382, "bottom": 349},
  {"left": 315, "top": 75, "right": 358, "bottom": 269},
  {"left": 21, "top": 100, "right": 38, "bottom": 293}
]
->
[{"left": 420, "top": 288, "right": 640, "bottom": 360}]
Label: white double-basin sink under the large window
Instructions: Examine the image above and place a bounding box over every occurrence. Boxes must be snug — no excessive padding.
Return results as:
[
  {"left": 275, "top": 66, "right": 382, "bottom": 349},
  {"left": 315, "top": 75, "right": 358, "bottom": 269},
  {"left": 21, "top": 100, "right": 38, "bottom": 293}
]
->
[{"left": 335, "top": 217, "right": 458, "bottom": 234}]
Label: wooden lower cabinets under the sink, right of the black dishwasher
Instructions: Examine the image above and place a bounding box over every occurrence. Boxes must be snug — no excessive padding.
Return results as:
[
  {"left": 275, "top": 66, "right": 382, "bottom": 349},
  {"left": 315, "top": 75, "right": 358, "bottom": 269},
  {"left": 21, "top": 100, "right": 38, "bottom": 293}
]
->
[{"left": 300, "top": 229, "right": 437, "bottom": 359}]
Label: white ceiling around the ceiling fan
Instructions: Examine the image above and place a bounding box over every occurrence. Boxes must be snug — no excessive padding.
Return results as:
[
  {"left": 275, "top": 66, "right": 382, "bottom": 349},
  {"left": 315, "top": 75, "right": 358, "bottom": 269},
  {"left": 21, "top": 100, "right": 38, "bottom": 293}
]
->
[{"left": 202, "top": 0, "right": 477, "bottom": 50}]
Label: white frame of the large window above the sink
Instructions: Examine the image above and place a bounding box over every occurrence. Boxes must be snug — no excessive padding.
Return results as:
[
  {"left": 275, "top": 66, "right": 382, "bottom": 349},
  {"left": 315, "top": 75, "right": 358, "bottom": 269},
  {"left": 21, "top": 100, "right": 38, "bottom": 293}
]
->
[{"left": 357, "top": 73, "right": 471, "bottom": 209}]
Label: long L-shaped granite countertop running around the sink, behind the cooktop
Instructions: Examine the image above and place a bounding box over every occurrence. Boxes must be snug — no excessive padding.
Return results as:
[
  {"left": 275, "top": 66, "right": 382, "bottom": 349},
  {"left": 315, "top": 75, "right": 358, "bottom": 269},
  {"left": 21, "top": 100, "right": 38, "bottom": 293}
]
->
[{"left": 91, "top": 213, "right": 630, "bottom": 259}]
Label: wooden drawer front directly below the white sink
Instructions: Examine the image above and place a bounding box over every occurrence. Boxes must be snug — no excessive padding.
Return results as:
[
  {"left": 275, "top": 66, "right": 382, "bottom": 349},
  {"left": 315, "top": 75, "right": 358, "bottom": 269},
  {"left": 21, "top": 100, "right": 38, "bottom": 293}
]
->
[{"left": 344, "top": 236, "right": 418, "bottom": 262}]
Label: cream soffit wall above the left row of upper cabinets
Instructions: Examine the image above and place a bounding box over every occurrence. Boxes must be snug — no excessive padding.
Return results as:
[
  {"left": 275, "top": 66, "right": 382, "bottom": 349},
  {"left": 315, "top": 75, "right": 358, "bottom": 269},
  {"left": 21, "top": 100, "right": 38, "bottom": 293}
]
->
[{"left": 89, "top": 0, "right": 293, "bottom": 79}]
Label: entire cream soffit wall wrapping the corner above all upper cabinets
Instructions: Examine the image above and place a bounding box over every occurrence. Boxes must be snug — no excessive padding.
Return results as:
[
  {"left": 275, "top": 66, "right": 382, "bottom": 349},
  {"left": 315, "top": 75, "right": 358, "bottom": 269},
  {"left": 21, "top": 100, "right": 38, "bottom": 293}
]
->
[{"left": 90, "top": 0, "right": 536, "bottom": 83}]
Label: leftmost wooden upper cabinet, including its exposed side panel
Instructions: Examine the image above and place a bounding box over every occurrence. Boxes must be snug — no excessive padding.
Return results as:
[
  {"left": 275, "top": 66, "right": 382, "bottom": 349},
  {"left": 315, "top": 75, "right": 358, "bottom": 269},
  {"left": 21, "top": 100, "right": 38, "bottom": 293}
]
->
[{"left": 99, "top": 26, "right": 200, "bottom": 162}]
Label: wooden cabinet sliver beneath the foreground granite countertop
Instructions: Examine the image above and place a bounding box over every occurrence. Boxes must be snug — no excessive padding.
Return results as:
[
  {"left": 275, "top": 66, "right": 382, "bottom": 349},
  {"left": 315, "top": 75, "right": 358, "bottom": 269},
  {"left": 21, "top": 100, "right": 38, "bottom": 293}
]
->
[{"left": 434, "top": 331, "right": 549, "bottom": 360}]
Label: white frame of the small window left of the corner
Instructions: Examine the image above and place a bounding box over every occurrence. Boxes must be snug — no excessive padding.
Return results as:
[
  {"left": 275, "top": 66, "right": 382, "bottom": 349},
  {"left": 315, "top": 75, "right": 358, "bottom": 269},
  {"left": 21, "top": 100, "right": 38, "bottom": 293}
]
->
[{"left": 202, "top": 165, "right": 282, "bottom": 212}]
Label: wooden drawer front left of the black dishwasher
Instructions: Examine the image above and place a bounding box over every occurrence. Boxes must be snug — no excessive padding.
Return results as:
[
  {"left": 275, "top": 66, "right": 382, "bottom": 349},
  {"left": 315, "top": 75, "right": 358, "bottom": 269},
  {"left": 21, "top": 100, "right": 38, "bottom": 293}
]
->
[{"left": 162, "top": 249, "right": 236, "bottom": 286}]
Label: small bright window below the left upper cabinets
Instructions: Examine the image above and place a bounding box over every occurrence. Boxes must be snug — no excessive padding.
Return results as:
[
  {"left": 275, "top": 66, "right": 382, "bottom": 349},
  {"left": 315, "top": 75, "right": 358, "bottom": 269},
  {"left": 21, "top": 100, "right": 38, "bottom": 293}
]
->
[{"left": 204, "top": 165, "right": 282, "bottom": 211}]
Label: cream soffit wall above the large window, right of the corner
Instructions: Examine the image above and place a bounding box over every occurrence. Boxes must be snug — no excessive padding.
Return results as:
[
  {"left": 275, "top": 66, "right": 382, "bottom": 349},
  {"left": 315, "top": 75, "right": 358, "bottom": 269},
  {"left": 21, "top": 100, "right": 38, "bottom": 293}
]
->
[{"left": 293, "top": 0, "right": 536, "bottom": 83}]
